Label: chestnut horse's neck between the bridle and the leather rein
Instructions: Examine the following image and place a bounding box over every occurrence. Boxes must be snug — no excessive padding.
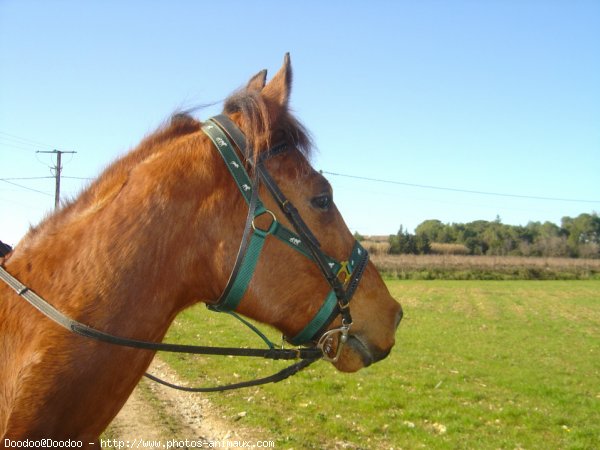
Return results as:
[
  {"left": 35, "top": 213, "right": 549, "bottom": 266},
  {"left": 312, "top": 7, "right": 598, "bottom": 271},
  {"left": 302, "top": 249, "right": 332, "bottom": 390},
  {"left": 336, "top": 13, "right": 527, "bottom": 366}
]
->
[{"left": 7, "top": 137, "right": 226, "bottom": 339}]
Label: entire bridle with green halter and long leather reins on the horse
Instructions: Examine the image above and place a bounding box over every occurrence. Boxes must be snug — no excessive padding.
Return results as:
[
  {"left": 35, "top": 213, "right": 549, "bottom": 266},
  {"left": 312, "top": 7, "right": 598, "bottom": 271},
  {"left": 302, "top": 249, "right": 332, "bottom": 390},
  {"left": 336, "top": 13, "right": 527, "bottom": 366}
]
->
[{"left": 0, "top": 115, "right": 368, "bottom": 392}]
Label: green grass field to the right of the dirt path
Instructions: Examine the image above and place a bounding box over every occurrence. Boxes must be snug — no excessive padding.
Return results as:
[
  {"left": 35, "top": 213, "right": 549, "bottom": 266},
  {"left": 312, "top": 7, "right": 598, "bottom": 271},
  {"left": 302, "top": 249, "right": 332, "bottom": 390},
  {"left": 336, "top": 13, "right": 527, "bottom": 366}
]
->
[{"left": 161, "top": 280, "right": 600, "bottom": 449}]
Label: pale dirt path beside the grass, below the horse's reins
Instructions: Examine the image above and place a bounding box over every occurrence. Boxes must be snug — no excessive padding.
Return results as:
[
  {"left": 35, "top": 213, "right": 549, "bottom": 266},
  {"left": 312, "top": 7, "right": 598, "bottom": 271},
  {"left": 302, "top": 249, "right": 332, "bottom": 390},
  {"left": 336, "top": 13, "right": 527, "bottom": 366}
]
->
[{"left": 105, "top": 358, "right": 257, "bottom": 448}]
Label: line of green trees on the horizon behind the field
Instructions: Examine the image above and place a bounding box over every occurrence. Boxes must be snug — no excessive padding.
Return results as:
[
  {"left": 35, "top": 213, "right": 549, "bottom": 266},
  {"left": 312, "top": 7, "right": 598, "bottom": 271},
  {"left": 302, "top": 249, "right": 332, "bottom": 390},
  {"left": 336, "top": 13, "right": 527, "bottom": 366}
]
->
[{"left": 389, "top": 212, "right": 600, "bottom": 258}]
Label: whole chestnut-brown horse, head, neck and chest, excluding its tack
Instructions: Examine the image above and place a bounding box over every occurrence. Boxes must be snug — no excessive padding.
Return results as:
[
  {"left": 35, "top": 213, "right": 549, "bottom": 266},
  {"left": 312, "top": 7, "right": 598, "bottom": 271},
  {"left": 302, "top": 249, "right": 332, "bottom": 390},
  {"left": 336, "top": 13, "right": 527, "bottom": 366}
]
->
[{"left": 0, "top": 56, "right": 402, "bottom": 446}]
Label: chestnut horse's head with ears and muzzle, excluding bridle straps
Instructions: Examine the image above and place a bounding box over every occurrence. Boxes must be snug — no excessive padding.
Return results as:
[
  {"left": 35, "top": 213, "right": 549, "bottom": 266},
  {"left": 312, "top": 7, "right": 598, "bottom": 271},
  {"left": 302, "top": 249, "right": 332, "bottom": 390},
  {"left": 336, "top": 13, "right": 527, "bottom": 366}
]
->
[{"left": 199, "top": 55, "right": 402, "bottom": 371}]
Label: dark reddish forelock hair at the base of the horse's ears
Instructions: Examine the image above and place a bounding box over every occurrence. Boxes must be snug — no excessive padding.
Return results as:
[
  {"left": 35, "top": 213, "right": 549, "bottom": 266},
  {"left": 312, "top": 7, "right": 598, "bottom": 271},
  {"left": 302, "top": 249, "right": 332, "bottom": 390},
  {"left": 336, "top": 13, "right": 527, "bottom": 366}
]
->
[{"left": 223, "top": 89, "right": 312, "bottom": 159}]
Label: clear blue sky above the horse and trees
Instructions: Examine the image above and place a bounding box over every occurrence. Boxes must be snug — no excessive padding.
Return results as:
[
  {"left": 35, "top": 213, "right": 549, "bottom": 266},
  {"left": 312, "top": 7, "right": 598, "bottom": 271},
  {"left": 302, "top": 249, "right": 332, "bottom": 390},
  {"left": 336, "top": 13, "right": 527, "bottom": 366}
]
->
[{"left": 0, "top": 0, "right": 600, "bottom": 244}]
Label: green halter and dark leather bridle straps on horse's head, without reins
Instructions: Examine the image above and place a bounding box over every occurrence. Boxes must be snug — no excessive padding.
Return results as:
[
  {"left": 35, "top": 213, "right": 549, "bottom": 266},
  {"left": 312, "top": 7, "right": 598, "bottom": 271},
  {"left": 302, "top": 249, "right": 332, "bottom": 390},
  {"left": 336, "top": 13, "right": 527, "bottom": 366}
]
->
[{"left": 202, "top": 115, "right": 368, "bottom": 362}]
